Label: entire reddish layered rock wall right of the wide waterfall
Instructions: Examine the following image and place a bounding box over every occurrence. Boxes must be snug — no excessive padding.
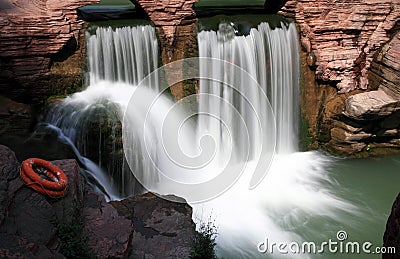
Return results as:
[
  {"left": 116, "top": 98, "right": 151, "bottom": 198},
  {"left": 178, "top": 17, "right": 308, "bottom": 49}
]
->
[{"left": 280, "top": 0, "right": 400, "bottom": 155}]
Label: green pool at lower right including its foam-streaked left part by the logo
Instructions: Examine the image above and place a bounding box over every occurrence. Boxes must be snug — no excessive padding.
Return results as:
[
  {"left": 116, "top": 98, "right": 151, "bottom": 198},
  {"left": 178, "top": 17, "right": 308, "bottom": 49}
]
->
[{"left": 274, "top": 152, "right": 400, "bottom": 259}]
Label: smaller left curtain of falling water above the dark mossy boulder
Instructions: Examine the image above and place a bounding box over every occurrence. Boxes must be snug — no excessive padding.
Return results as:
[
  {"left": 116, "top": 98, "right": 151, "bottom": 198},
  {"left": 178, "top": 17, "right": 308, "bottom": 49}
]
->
[{"left": 86, "top": 25, "right": 158, "bottom": 90}]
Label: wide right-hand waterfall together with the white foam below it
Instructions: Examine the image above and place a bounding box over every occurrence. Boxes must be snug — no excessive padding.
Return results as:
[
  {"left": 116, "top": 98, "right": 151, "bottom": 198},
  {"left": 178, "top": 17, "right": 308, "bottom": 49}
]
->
[{"left": 191, "top": 23, "right": 357, "bottom": 258}]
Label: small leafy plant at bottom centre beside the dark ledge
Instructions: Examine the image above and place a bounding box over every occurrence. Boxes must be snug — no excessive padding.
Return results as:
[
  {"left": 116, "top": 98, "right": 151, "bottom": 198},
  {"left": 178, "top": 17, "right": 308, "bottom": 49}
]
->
[{"left": 190, "top": 217, "right": 217, "bottom": 259}]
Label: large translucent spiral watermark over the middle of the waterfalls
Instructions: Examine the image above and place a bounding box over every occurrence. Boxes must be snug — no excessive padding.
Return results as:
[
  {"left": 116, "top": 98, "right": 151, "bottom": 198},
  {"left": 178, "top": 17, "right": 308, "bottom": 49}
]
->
[{"left": 122, "top": 58, "right": 276, "bottom": 203}]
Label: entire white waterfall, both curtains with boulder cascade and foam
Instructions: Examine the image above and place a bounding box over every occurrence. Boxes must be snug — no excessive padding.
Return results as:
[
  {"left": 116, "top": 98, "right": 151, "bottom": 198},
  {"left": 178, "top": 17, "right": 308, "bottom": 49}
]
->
[{"left": 39, "top": 23, "right": 396, "bottom": 258}]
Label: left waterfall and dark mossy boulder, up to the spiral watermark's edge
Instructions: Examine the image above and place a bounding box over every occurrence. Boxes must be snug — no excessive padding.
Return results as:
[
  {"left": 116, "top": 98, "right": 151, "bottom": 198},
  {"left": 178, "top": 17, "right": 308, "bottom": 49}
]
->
[{"left": 44, "top": 26, "right": 159, "bottom": 199}]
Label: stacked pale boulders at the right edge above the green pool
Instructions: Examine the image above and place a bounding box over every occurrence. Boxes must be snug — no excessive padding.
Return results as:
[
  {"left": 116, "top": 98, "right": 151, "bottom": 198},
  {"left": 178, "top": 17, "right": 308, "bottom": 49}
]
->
[{"left": 330, "top": 32, "right": 400, "bottom": 154}]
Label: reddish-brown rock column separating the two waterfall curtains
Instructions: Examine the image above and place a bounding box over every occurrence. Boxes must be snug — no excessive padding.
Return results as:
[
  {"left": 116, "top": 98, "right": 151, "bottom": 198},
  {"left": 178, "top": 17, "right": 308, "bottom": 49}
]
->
[{"left": 131, "top": 0, "right": 198, "bottom": 100}]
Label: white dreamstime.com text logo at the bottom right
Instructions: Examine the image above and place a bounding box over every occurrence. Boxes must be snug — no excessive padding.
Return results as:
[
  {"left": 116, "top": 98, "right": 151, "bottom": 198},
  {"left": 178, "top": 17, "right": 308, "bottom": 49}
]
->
[{"left": 257, "top": 230, "right": 396, "bottom": 254}]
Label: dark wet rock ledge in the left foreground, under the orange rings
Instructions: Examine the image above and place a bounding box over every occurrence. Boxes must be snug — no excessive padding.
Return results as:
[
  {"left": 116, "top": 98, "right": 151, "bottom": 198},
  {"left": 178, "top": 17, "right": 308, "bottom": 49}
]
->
[{"left": 0, "top": 145, "right": 195, "bottom": 258}]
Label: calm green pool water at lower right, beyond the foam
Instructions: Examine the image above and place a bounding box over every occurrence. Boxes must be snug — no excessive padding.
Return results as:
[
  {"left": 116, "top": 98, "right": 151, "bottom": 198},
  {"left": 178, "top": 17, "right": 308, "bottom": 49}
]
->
[{"left": 324, "top": 156, "right": 400, "bottom": 258}]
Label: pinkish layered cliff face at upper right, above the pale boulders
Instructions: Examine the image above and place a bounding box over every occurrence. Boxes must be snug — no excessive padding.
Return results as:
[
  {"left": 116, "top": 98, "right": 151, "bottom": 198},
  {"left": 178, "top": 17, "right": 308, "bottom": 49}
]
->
[{"left": 281, "top": 0, "right": 400, "bottom": 93}]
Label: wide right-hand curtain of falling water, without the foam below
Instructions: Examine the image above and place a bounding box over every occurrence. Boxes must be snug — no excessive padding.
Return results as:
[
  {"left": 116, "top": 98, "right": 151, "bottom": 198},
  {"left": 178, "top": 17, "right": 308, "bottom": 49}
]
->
[{"left": 198, "top": 23, "right": 299, "bottom": 154}]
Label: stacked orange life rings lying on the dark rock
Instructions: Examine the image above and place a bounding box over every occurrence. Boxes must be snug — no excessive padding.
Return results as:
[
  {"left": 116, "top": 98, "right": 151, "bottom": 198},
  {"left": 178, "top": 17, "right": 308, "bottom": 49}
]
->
[{"left": 20, "top": 158, "right": 68, "bottom": 198}]
